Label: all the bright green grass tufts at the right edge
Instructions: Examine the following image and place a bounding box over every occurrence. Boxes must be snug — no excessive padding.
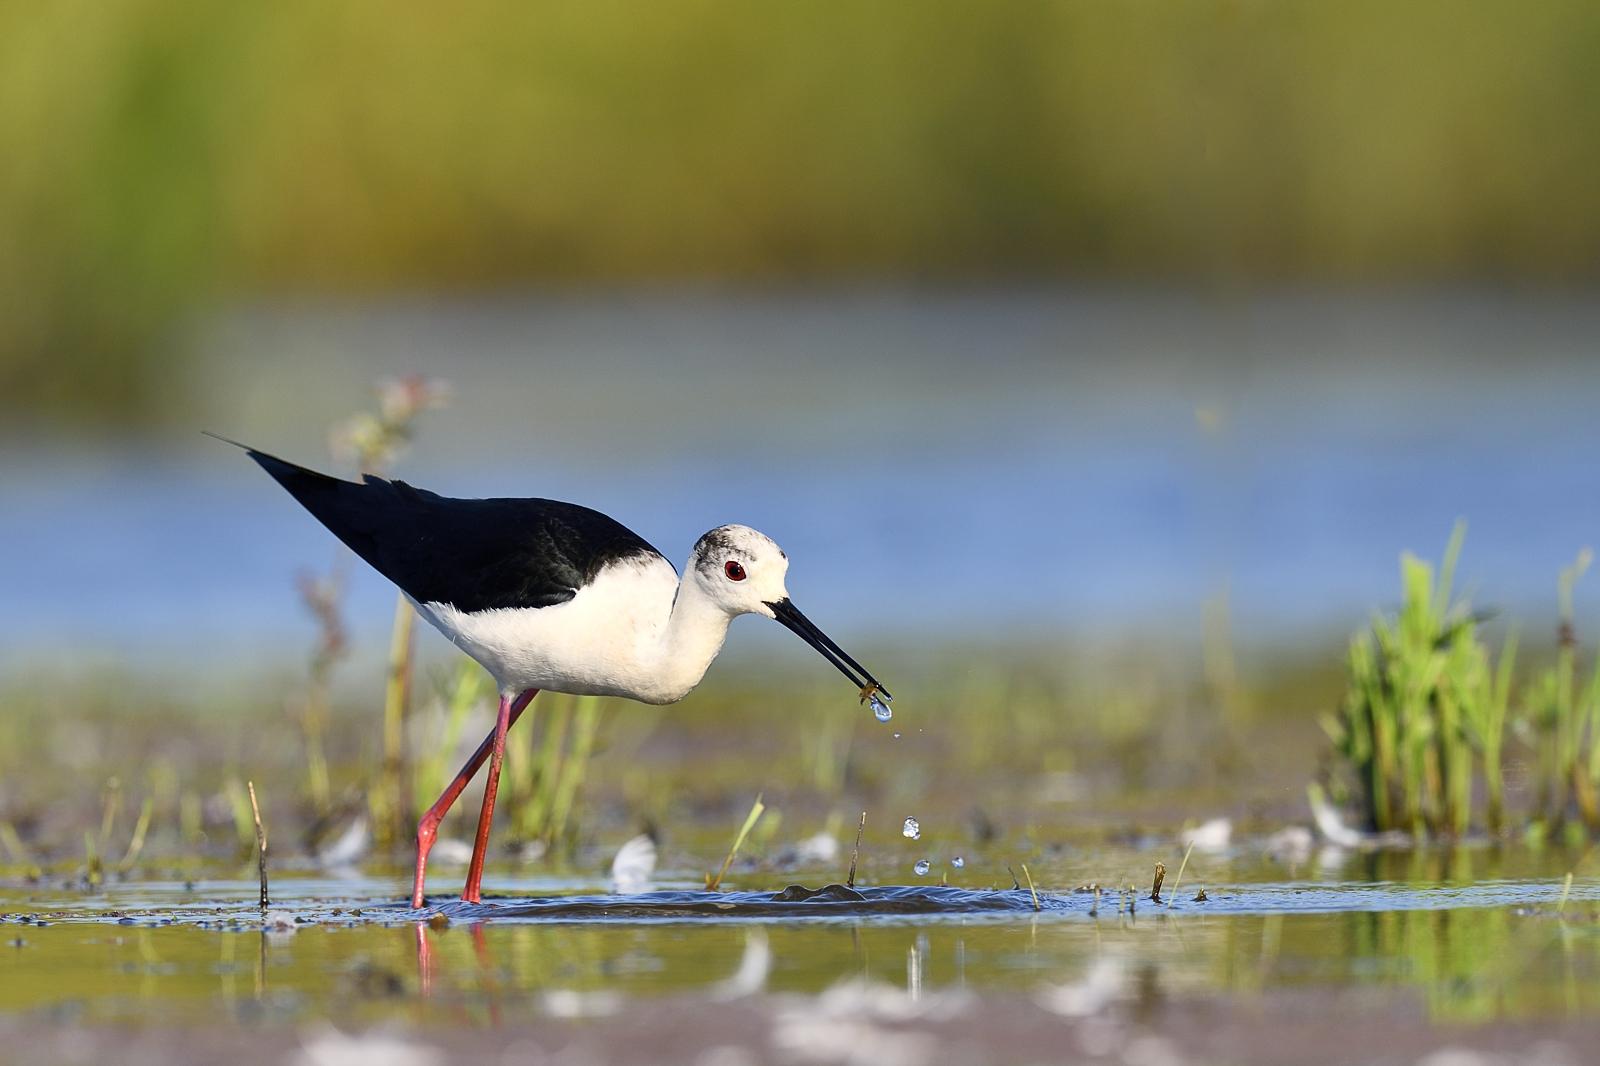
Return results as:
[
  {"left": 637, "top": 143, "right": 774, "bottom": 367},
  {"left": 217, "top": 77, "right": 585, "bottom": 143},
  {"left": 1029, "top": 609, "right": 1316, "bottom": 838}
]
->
[{"left": 1325, "top": 525, "right": 1600, "bottom": 837}]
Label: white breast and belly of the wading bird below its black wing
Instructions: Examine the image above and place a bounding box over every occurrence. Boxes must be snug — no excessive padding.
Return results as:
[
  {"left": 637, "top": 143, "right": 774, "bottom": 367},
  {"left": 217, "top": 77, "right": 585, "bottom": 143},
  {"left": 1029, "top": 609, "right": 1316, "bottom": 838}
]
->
[{"left": 416, "top": 555, "right": 682, "bottom": 703}]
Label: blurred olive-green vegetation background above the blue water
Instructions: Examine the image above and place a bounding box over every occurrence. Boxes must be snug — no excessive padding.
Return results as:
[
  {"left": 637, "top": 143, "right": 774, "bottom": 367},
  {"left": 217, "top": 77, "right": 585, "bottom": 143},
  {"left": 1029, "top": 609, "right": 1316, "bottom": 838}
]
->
[{"left": 0, "top": 0, "right": 1600, "bottom": 431}]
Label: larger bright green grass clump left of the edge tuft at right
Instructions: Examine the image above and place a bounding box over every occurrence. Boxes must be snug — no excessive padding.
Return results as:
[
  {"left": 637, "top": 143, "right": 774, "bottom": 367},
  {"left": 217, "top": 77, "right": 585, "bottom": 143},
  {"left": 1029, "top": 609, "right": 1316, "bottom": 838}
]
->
[{"left": 1326, "top": 525, "right": 1515, "bottom": 836}]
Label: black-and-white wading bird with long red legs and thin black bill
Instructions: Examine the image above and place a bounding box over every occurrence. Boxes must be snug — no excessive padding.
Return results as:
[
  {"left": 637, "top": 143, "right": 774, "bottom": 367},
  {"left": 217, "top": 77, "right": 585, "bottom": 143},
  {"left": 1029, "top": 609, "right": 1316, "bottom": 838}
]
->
[{"left": 227, "top": 440, "right": 893, "bottom": 908}]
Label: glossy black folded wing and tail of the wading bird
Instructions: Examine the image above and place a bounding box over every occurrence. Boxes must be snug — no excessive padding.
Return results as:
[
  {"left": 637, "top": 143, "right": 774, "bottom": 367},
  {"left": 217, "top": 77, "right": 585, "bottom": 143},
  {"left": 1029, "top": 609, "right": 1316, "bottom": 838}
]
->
[{"left": 233, "top": 438, "right": 661, "bottom": 611}]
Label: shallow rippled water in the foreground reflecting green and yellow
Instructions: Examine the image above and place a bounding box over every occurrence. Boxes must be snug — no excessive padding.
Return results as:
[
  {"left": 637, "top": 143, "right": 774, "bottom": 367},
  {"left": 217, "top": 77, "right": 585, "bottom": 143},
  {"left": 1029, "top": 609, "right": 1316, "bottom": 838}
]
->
[{"left": 0, "top": 848, "right": 1600, "bottom": 1024}]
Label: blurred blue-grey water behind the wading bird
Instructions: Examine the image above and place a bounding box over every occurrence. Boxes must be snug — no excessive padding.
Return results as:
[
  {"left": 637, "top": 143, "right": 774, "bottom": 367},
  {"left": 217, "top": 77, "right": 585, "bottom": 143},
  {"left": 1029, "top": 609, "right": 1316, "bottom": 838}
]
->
[{"left": 9, "top": 290, "right": 1600, "bottom": 656}]
